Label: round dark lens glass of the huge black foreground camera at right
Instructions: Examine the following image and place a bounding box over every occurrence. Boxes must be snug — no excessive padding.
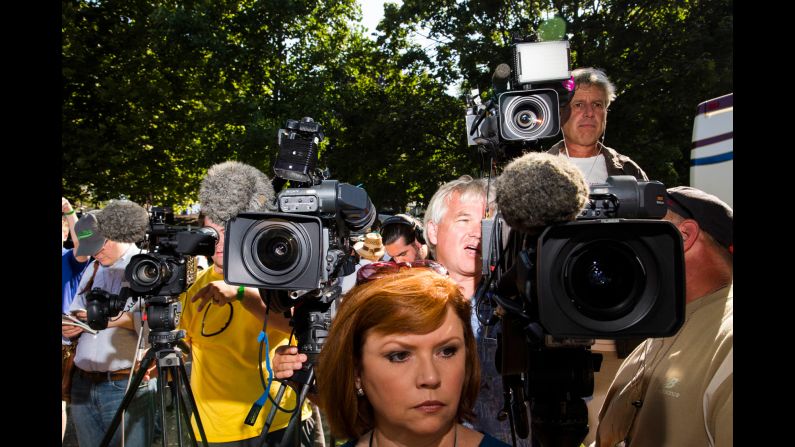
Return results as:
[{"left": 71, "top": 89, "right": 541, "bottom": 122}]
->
[{"left": 564, "top": 240, "right": 646, "bottom": 320}]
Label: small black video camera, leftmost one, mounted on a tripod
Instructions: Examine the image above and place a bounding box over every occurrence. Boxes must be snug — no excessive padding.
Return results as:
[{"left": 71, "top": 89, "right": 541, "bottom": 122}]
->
[{"left": 86, "top": 207, "right": 218, "bottom": 330}]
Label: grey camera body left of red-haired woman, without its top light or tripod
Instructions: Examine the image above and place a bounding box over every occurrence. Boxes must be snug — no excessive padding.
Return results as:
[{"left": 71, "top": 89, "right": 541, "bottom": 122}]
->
[{"left": 224, "top": 180, "right": 375, "bottom": 290}]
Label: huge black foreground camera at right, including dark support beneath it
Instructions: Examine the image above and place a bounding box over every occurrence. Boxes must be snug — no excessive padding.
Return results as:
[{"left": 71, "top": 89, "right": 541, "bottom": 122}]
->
[{"left": 475, "top": 176, "right": 685, "bottom": 446}]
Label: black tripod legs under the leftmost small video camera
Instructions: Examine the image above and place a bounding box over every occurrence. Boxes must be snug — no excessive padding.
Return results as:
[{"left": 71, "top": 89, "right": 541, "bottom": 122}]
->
[{"left": 100, "top": 297, "right": 207, "bottom": 447}]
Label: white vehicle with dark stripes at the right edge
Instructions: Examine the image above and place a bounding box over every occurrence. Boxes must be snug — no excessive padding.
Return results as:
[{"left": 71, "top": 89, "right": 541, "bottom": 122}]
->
[{"left": 690, "top": 93, "right": 734, "bottom": 207}]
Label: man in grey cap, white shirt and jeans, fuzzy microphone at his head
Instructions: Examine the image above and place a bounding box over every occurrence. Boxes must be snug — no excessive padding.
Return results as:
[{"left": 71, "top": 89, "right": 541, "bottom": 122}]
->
[{"left": 61, "top": 200, "right": 156, "bottom": 446}]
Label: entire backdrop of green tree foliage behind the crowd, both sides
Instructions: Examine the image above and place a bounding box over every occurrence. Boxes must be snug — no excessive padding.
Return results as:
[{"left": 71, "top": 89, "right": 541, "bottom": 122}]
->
[{"left": 62, "top": 0, "right": 733, "bottom": 210}]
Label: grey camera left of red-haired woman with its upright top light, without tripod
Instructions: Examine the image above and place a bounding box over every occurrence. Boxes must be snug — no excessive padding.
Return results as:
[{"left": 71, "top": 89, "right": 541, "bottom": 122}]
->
[{"left": 224, "top": 117, "right": 376, "bottom": 296}]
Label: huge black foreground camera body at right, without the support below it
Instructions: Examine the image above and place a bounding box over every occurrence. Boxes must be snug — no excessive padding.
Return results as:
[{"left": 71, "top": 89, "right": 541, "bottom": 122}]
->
[{"left": 483, "top": 176, "right": 685, "bottom": 339}]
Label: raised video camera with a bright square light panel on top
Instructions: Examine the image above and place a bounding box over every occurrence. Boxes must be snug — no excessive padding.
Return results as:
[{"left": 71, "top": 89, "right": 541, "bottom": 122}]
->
[{"left": 466, "top": 40, "right": 571, "bottom": 152}]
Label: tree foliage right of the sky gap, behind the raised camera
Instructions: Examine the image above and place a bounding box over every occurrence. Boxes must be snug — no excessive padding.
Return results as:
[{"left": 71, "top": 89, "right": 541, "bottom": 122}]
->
[{"left": 379, "top": 0, "right": 733, "bottom": 185}]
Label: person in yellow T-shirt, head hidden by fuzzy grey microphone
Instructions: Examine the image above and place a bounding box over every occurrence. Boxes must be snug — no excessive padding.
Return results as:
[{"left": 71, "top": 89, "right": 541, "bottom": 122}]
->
[{"left": 179, "top": 161, "right": 314, "bottom": 447}]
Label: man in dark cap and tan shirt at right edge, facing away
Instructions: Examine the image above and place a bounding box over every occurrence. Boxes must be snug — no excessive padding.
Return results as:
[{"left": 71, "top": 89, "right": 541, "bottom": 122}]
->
[{"left": 595, "top": 186, "right": 734, "bottom": 447}]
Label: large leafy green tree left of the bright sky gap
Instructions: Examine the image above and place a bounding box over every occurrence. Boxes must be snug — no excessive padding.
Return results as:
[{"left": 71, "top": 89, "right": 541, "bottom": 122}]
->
[{"left": 62, "top": 0, "right": 474, "bottom": 209}]
